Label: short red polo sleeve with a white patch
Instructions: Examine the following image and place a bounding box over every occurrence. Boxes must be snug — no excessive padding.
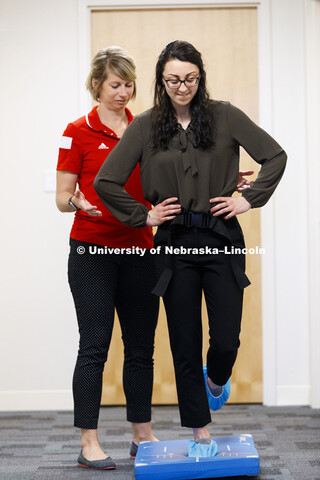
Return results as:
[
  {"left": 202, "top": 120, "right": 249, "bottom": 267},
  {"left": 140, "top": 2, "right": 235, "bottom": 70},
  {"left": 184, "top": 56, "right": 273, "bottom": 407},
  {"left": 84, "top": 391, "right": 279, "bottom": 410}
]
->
[{"left": 57, "top": 123, "right": 82, "bottom": 175}]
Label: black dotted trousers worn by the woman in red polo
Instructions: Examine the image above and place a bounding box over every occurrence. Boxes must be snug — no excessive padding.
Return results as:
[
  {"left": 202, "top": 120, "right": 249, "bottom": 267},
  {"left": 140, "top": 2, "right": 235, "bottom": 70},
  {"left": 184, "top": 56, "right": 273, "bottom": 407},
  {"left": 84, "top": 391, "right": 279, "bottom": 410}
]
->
[{"left": 68, "top": 239, "right": 159, "bottom": 429}]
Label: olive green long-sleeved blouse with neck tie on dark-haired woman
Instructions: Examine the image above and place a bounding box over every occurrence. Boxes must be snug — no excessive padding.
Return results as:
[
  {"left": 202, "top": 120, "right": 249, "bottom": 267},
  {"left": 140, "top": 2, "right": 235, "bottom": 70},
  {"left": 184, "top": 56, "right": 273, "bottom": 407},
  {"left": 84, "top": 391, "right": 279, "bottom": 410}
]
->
[{"left": 94, "top": 101, "right": 287, "bottom": 227}]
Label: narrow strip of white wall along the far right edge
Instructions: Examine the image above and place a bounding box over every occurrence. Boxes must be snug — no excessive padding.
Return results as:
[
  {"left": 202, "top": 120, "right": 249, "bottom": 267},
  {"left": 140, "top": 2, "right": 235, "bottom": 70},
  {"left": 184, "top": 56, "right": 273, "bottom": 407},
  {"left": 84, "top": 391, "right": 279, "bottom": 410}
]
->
[{"left": 305, "top": 0, "right": 320, "bottom": 408}]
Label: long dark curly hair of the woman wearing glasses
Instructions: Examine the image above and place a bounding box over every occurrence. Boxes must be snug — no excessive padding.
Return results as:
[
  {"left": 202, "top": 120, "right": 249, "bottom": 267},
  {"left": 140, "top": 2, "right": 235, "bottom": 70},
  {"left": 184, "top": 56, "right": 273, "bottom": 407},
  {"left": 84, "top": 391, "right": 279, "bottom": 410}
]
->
[{"left": 152, "top": 40, "right": 213, "bottom": 149}]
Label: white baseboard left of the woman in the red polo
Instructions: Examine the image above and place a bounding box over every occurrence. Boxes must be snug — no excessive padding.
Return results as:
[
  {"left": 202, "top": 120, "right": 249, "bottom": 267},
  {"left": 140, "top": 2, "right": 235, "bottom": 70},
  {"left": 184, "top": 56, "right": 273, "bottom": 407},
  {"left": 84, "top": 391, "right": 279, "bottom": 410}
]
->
[{"left": 0, "top": 390, "right": 73, "bottom": 412}]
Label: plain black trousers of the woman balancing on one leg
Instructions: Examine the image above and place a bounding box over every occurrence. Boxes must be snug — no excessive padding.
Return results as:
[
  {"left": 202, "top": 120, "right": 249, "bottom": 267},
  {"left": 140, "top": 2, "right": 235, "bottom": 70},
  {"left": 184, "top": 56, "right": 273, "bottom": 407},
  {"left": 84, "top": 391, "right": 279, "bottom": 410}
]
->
[{"left": 155, "top": 226, "right": 243, "bottom": 428}]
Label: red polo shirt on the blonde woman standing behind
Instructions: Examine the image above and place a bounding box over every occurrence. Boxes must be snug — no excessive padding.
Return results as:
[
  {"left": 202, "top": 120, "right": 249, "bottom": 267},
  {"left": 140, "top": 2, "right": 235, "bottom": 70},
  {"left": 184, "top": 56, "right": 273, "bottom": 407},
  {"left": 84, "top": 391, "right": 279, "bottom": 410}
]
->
[{"left": 57, "top": 107, "right": 153, "bottom": 248}]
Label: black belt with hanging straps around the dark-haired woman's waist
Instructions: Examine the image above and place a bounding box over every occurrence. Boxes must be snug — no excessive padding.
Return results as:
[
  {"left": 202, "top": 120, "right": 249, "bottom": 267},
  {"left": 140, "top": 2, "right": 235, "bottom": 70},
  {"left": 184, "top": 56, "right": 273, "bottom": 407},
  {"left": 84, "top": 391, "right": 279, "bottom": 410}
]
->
[{"left": 152, "top": 212, "right": 250, "bottom": 296}]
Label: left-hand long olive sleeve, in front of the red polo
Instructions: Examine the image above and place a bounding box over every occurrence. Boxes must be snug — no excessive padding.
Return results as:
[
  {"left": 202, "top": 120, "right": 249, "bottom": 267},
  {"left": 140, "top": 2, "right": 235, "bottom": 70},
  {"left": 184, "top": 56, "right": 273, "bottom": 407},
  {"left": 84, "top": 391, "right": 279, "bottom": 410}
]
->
[{"left": 93, "top": 118, "right": 148, "bottom": 227}]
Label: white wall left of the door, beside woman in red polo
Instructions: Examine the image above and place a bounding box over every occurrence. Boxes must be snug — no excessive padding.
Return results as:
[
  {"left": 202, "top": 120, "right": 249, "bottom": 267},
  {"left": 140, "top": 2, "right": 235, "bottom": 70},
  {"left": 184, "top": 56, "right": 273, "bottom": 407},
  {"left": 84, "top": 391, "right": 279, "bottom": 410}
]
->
[{"left": 0, "top": 0, "right": 79, "bottom": 409}]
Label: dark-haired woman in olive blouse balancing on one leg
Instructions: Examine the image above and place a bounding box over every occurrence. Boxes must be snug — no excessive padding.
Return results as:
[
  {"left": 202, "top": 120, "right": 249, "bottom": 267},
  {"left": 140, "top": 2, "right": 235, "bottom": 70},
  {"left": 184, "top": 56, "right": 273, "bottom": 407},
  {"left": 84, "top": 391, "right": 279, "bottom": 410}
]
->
[{"left": 94, "top": 41, "right": 286, "bottom": 443}]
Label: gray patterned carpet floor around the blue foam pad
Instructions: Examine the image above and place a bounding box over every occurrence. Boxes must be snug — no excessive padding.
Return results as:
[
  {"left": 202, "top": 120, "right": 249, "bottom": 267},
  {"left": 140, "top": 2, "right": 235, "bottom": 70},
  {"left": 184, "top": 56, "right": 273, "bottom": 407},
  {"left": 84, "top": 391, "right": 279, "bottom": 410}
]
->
[{"left": 0, "top": 405, "right": 320, "bottom": 480}]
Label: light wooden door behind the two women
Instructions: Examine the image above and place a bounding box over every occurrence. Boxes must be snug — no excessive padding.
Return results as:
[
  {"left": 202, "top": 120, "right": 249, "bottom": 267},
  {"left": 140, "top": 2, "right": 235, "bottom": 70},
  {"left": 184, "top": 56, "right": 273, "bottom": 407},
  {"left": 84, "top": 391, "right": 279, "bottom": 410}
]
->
[{"left": 91, "top": 8, "right": 262, "bottom": 405}]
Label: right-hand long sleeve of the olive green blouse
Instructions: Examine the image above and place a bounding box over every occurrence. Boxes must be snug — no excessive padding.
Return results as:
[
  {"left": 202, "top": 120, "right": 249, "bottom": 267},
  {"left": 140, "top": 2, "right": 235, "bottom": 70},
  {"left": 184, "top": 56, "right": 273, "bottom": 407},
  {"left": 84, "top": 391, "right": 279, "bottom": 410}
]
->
[{"left": 227, "top": 105, "right": 287, "bottom": 207}]
